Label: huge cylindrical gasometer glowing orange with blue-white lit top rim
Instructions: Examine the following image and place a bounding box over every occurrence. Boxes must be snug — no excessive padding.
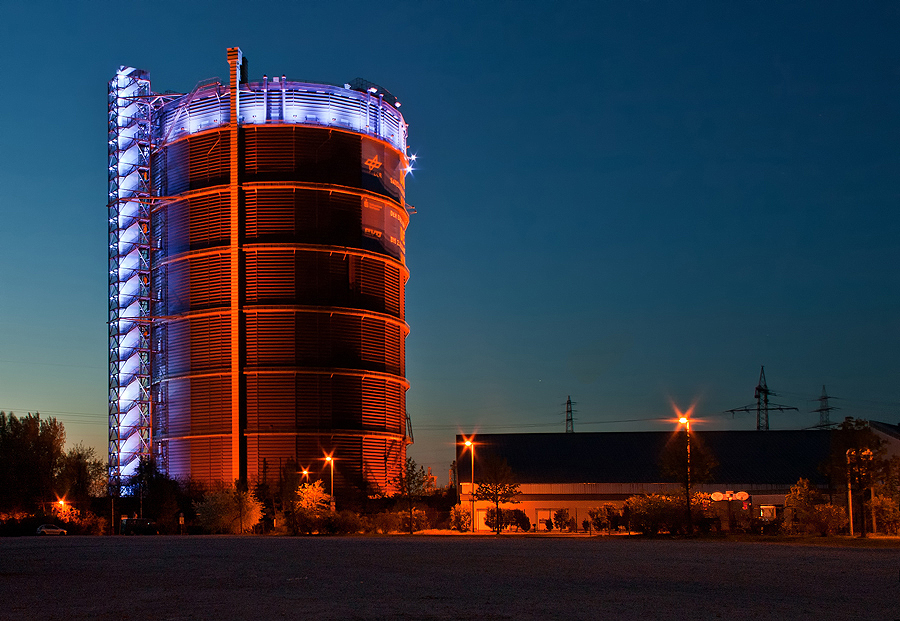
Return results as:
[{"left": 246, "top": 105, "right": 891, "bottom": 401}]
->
[{"left": 110, "top": 48, "right": 409, "bottom": 494}]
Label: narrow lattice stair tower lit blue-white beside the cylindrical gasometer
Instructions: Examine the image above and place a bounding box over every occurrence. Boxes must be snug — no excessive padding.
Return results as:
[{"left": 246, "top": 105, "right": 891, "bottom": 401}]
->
[{"left": 108, "top": 67, "right": 152, "bottom": 493}]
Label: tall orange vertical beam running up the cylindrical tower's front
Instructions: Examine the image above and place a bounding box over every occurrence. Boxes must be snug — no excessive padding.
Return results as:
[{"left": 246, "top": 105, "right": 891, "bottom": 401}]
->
[{"left": 228, "top": 47, "right": 246, "bottom": 481}]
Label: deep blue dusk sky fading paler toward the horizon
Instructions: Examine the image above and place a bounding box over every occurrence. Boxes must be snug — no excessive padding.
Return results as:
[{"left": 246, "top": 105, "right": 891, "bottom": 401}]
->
[{"left": 0, "top": 0, "right": 900, "bottom": 482}]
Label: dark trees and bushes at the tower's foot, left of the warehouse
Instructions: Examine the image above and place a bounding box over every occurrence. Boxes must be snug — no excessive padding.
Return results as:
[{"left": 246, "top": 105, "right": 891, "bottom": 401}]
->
[{"left": 0, "top": 412, "right": 456, "bottom": 534}]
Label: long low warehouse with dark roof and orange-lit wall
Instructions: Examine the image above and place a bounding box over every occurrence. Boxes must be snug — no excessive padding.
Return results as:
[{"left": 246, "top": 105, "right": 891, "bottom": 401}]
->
[{"left": 456, "top": 422, "right": 900, "bottom": 530}]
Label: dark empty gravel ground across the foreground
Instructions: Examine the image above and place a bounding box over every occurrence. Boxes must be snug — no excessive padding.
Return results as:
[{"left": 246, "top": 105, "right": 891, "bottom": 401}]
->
[{"left": 0, "top": 536, "right": 900, "bottom": 621}]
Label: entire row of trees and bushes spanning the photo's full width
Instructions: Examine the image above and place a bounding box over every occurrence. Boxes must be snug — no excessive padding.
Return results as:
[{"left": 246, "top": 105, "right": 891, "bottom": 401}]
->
[{"left": 0, "top": 412, "right": 900, "bottom": 535}]
